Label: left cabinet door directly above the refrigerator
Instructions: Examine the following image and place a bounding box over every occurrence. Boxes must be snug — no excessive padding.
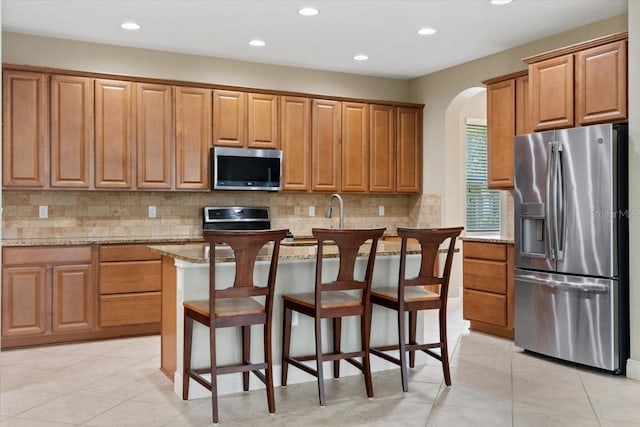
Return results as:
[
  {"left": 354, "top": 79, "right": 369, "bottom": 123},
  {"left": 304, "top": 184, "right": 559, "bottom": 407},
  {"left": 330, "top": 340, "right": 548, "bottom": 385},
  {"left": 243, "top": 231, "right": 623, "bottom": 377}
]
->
[{"left": 529, "top": 55, "right": 575, "bottom": 130}]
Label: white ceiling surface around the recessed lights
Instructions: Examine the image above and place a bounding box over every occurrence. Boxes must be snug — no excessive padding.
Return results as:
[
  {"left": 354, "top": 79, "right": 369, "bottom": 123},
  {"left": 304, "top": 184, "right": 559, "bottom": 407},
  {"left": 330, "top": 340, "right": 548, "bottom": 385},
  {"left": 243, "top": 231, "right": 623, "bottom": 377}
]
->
[{"left": 0, "top": 0, "right": 627, "bottom": 78}]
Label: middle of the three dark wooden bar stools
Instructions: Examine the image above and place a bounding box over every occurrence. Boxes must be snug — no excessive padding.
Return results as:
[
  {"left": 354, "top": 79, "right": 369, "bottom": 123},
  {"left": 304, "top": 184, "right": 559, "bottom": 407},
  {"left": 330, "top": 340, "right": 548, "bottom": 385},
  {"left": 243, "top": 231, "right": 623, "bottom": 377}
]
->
[{"left": 282, "top": 228, "right": 385, "bottom": 406}]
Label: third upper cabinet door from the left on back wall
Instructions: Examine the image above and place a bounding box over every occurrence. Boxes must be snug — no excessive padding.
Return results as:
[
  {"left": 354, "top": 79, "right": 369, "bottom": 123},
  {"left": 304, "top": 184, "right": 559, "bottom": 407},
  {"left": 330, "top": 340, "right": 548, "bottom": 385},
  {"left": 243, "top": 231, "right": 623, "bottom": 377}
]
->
[{"left": 95, "top": 80, "right": 133, "bottom": 188}]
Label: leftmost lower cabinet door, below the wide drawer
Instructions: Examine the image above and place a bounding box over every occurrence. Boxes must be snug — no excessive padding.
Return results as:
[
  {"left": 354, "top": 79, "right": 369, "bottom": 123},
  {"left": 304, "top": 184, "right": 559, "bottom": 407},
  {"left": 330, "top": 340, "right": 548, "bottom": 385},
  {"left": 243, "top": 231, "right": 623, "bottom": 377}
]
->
[{"left": 2, "top": 266, "right": 47, "bottom": 337}]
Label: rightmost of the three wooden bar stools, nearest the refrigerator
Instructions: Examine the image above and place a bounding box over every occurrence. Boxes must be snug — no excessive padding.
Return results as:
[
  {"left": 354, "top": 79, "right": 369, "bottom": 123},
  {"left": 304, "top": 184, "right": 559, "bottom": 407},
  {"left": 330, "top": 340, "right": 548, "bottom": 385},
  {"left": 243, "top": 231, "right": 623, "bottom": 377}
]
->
[{"left": 371, "top": 227, "right": 464, "bottom": 392}]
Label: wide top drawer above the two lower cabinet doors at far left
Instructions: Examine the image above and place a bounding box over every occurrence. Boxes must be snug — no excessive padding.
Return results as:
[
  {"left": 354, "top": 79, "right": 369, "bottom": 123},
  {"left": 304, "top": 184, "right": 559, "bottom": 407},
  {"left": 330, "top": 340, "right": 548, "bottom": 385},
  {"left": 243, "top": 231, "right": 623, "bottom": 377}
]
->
[{"left": 2, "top": 245, "right": 91, "bottom": 265}]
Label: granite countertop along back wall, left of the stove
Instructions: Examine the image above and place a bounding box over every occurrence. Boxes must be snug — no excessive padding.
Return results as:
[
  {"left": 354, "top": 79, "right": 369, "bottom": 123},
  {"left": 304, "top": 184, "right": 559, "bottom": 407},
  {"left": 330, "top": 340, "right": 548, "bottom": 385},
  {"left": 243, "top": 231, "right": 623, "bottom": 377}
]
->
[{"left": 2, "top": 236, "right": 202, "bottom": 247}]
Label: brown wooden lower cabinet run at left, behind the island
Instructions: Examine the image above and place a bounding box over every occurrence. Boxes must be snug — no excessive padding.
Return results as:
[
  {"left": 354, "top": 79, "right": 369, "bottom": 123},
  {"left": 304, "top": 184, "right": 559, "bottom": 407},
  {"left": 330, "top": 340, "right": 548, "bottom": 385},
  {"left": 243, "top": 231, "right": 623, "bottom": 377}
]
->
[{"left": 1, "top": 244, "right": 162, "bottom": 349}]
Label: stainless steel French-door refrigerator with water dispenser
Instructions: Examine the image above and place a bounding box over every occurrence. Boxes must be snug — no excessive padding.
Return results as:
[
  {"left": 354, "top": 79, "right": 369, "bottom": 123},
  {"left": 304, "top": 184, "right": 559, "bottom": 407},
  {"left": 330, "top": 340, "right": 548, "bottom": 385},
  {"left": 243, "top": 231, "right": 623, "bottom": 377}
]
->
[{"left": 514, "top": 124, "right": 629, "bottom": 374}]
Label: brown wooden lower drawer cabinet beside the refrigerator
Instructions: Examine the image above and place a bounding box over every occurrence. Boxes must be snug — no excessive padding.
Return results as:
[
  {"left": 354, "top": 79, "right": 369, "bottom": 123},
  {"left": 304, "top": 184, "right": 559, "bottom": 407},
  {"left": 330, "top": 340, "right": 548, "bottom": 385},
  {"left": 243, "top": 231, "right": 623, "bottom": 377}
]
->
[{"left": 462, "top": 241, "right": 514, "bottom": 339}]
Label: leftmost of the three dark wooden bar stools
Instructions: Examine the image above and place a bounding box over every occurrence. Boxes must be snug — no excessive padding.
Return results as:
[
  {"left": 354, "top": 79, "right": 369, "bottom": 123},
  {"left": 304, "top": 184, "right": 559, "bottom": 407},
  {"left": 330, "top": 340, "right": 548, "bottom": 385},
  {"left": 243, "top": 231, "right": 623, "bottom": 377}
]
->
[{"left": 182, "top": 230, "right": 289, "bottom": 423}]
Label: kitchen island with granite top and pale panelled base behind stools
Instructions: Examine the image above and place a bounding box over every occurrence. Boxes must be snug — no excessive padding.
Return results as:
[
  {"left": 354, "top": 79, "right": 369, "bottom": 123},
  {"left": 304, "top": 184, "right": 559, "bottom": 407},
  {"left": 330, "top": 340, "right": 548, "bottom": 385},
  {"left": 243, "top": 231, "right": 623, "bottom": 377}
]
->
[{"left": 149, "top": 239, "right": 426, "bottom": 398}]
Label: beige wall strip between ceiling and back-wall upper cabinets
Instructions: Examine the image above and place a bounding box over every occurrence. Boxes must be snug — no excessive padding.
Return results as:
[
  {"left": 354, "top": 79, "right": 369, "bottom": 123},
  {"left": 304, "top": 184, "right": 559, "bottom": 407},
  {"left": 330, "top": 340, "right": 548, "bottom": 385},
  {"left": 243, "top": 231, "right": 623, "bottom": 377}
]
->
[{"left": 2, "top": 32, "right": 409, "bottom": 101}]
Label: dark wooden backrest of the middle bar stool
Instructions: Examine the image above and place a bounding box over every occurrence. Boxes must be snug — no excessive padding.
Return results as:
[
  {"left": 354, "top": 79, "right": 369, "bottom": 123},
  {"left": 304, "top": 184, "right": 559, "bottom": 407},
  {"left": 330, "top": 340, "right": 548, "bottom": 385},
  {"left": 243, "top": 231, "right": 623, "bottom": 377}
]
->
[{"left": 311, "top": 228, "right": 385, "bottom": 309}]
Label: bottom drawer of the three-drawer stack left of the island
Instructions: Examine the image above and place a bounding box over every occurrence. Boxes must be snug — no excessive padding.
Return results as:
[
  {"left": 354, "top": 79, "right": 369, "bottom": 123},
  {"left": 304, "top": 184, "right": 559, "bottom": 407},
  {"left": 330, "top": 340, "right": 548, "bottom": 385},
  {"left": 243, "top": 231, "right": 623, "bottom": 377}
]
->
[{"left": 100, "top": 292, "right": 161, "bottom": 327}]
